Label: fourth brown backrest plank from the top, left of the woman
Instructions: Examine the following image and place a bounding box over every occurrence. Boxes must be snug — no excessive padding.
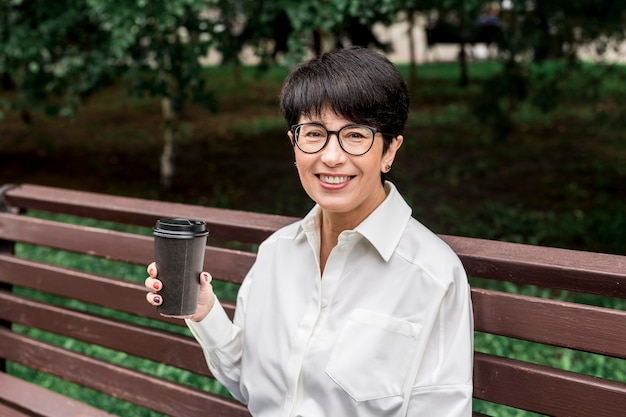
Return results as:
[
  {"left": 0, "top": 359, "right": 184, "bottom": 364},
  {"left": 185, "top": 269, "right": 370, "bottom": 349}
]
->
[{"left": 0, "top": 292, "right": 211, "bottom": 376}]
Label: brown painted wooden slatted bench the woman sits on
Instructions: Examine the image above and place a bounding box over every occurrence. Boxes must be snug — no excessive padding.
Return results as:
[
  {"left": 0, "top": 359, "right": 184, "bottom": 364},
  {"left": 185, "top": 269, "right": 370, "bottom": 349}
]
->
[{"left": 0, "top": 184, "right": 626, "bottom": 417}]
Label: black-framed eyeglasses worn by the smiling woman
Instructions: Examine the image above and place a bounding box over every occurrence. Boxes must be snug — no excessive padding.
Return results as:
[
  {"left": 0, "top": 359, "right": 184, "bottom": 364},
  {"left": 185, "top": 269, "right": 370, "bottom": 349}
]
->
[{"left": 291, "top": 123, "right": 382, "bottom": 156}]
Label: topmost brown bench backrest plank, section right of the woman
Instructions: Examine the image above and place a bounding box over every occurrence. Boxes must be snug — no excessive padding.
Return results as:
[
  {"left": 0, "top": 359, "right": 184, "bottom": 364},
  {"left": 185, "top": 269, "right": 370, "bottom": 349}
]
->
[{"left": 441, "top": 235, "right": 626, "bottom": 298}]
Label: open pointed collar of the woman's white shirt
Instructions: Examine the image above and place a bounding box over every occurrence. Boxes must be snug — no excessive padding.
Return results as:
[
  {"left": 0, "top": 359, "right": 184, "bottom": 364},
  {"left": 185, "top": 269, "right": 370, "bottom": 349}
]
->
[{"left": 293, "top": 181, "right": 411, "bottom": 261}]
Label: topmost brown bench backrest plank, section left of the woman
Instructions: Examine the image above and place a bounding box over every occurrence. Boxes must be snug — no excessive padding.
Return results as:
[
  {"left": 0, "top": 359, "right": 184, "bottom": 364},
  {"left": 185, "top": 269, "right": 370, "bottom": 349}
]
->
[{"left": 6, "top": 184, "right": 297, "bottom": 243}]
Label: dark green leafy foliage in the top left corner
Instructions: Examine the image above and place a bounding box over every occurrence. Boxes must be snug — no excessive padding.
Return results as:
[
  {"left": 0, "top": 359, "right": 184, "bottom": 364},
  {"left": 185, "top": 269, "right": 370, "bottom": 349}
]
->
[{"left": 0, "top": 0, "right": 119, "bottom": 123}]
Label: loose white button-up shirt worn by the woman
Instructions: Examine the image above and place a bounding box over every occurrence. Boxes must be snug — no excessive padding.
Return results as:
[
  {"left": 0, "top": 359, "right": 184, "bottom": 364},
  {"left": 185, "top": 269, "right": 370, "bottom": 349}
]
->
[{"left": 188, "top": 183, "right": 473, "bottom": 417}]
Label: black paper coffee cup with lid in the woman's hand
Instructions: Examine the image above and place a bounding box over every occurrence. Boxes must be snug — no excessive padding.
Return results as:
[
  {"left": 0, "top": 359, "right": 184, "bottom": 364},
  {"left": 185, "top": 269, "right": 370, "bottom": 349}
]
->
[{"left": 152, "top": 218, "right": 209, "bottom": 317}]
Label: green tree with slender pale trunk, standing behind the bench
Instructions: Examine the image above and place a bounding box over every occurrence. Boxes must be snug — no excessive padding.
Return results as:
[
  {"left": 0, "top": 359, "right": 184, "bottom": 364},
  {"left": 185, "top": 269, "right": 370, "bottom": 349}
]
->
[{"left": 87, "top": 0, "right": 222, "bottom": 189}]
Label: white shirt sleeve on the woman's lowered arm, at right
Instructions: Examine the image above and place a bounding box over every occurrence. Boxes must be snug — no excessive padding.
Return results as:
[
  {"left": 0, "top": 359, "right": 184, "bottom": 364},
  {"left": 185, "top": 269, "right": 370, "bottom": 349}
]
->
[{"left": 406, "top": 267, "right": 474, "bottom": 417}]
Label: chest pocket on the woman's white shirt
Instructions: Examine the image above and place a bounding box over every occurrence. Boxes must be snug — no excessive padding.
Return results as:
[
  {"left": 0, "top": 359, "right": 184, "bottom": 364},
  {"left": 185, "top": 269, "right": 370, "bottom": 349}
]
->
[{"left": 325, "top": 309, "right": 421, "bottom": 401}]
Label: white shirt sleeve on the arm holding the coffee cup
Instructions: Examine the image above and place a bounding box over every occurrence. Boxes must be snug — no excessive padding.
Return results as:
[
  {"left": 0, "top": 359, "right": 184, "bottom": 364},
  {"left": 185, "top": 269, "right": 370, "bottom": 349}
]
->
[{"left": 185, "top": 271, "right": 252, "bottom": 404}]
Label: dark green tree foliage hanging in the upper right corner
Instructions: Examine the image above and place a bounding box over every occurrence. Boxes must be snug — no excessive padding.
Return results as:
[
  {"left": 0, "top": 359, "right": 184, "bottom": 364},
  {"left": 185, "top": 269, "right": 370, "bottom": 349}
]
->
[{"left": 473, "top": 0, "right": 626, "bottom": 138}]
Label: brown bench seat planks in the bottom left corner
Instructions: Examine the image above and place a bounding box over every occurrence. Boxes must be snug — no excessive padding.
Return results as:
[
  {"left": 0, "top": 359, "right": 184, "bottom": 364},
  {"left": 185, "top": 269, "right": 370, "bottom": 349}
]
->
[{"left": 0, "top": 373, "right": 113, "bottom": 417}]
